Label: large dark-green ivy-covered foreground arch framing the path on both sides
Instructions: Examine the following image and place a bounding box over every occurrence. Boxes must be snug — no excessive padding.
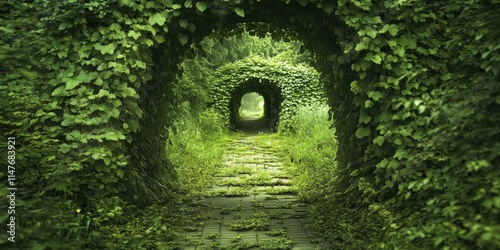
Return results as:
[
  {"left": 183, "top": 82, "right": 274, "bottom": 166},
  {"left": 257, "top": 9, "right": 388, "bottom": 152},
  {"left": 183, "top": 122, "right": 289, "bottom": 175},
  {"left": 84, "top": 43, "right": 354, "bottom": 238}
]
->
[{"left": 0, "top": 0, "right": 500, "bottom": 249}]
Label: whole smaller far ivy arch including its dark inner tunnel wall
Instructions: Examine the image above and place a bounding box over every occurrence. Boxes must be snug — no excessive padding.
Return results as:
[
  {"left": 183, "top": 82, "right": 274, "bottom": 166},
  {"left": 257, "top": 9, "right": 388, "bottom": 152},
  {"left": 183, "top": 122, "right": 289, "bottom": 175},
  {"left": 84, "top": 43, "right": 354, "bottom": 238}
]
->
[{"left": 209, "top": 56, "right": 326, "bottom": 128}]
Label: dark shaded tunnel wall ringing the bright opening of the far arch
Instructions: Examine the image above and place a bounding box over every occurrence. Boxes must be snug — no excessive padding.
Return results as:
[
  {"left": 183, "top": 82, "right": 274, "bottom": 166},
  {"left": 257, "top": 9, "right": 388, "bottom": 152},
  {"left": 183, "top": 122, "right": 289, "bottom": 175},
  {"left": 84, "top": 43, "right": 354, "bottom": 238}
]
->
[{"left": 229, "top": 79, "right": 283, "bottom": 132}]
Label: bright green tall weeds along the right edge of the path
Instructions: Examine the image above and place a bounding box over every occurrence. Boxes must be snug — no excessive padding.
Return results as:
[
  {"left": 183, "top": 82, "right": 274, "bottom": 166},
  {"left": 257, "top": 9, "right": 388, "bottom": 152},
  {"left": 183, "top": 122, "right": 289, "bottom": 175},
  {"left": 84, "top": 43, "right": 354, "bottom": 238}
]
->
[{"left": 279, "top": 105, "right": 337, "bottom": 202}]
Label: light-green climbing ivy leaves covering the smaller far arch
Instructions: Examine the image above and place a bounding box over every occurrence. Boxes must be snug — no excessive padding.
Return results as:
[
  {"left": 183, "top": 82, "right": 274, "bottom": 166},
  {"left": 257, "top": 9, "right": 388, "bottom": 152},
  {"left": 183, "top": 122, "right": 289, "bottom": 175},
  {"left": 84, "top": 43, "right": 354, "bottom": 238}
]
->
[{"left": 209, "top": 56, "right": 326, "bottom": 127}]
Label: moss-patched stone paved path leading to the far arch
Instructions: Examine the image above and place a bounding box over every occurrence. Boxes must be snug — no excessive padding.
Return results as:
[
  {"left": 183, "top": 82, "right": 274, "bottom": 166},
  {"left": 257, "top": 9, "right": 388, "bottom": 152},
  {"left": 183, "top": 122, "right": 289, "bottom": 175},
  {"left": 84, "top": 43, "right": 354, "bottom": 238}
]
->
[{"left": 179, "top": 135, "right": 321, "bottom": 250}]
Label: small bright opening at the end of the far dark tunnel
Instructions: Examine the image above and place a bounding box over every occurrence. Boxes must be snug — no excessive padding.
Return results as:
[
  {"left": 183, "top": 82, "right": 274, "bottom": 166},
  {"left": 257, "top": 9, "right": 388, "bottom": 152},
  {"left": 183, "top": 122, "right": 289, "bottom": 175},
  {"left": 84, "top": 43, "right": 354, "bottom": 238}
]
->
[{"left": 238, "top": 92, "right": 266, "bottom": 121}]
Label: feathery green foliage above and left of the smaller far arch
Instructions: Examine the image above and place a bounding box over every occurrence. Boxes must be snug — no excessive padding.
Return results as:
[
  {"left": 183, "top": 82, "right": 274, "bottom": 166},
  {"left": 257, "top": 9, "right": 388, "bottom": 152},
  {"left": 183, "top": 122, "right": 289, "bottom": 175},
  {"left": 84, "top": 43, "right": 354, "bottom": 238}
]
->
[{"left": 173, "top": 29, "right": 312, "bottom": 110}]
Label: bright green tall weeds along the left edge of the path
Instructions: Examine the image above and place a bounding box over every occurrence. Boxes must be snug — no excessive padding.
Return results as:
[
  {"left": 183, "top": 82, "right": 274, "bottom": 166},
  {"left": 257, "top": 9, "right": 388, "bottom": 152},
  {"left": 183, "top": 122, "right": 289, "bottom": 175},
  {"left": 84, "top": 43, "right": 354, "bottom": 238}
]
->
[{"left": 166, "top": 102, "right": 226, "bottom": 194}]
